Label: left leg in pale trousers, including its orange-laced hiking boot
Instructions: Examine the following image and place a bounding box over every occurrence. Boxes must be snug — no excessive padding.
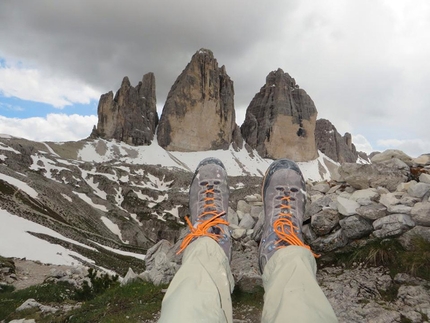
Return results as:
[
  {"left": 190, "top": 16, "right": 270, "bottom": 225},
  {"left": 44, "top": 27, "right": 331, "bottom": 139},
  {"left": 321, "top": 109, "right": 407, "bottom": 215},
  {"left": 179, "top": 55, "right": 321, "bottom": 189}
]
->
[{"left": 159, "top": 158, "right": 234, "bottom": 323}]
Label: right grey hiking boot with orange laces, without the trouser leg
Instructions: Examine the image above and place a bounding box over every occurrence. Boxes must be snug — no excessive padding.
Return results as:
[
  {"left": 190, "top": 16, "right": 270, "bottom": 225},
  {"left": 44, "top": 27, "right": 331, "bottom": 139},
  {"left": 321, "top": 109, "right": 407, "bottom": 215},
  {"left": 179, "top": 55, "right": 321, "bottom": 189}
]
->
[{"left": 259, "top": 159, "right": 316, "bottom": 273}]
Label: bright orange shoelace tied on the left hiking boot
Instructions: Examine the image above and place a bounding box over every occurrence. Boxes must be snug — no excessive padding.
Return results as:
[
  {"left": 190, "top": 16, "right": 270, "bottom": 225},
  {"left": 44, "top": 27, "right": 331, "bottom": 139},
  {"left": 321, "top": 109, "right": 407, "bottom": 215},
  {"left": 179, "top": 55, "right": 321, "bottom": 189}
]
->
[{"left": 176, "top": 185, "right": 229, "bottom": 254}]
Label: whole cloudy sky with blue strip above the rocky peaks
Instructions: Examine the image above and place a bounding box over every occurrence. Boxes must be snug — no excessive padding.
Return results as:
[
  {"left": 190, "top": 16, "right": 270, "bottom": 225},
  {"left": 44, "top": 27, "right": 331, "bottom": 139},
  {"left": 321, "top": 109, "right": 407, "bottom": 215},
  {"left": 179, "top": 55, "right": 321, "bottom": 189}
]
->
[{"left": 0, "top": 0, "right": 430, "bottom": 157}]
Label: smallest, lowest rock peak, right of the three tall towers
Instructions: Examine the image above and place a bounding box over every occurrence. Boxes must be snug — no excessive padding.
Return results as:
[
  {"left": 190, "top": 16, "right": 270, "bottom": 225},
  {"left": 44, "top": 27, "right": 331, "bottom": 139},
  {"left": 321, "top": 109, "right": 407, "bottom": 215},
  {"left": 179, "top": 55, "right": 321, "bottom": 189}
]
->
[{"left": 315, "top": 119, "right": 358, "bottom": 163}]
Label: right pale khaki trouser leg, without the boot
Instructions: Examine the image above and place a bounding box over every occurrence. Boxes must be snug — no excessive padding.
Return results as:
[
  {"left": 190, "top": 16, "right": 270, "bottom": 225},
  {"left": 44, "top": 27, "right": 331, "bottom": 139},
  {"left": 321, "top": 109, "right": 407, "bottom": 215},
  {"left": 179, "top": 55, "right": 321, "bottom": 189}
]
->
[{"left": 262, "top": 246, "right": 337, "bottom": 323}]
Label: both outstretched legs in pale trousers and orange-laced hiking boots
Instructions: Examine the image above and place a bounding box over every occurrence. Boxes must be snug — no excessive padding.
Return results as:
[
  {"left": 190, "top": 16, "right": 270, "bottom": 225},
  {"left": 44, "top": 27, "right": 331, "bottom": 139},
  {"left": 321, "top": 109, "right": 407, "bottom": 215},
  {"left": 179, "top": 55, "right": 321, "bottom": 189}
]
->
[{"left": 159, "top": 158, "right": 337, "bottom": 323}]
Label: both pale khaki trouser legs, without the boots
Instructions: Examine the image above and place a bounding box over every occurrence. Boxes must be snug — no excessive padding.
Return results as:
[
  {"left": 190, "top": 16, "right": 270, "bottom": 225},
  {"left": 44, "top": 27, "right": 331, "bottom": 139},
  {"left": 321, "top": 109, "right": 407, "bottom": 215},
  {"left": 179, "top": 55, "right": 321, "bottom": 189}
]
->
[{"left": 159, "top": 237, "right": 337, "bottom": 323}]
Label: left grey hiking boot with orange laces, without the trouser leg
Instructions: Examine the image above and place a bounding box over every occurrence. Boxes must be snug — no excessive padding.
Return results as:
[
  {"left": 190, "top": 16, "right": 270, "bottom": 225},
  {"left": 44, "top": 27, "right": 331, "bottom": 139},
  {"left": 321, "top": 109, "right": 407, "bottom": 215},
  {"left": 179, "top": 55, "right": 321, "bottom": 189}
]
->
[{"left": 178, "top": 157, "right": 231, "bottom": 260}]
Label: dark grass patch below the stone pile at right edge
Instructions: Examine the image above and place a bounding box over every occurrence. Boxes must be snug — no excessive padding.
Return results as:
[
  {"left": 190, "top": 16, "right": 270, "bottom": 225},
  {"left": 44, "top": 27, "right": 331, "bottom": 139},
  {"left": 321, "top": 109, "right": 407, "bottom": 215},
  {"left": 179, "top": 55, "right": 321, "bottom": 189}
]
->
[{"left": 322, "top": 236, "right": 430, "bottom": 280}]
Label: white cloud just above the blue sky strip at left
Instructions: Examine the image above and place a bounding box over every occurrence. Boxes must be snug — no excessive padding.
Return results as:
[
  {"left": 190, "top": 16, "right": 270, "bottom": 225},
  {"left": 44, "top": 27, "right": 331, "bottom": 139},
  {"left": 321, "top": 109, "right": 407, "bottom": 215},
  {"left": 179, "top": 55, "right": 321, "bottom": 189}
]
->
[{"left": 0, "top": 63, "right": 100, "bottom": 108}]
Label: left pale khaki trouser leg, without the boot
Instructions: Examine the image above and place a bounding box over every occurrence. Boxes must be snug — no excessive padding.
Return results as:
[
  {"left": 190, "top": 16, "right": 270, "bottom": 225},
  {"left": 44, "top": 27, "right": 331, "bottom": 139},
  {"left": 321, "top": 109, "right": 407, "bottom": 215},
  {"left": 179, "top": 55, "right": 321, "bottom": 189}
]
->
[{"left": 159, "top": 237, "right": 234, "bottom": 323}]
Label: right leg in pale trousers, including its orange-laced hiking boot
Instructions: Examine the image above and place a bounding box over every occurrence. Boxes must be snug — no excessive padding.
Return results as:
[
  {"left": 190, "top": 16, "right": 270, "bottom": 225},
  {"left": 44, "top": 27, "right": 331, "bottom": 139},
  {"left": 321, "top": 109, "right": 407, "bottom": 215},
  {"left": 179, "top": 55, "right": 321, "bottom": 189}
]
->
[{"left": 259, "top": 159, "right": 337, "bottom": 323}]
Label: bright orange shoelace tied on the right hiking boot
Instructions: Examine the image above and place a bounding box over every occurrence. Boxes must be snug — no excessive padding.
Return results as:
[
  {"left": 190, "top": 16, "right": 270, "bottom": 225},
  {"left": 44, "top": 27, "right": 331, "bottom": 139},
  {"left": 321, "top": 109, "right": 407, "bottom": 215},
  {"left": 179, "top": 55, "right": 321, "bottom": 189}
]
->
[{"left": 273, "top": 196, "right": 320, "bottom": 258}]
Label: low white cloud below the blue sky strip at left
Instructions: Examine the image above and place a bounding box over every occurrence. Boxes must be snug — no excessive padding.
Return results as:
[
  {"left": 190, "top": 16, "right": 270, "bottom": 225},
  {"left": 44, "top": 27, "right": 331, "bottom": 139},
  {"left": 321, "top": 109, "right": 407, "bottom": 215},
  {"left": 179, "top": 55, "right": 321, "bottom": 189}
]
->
[{"left": 0, "top": 113, "right": 97, "bottom": 141}]
